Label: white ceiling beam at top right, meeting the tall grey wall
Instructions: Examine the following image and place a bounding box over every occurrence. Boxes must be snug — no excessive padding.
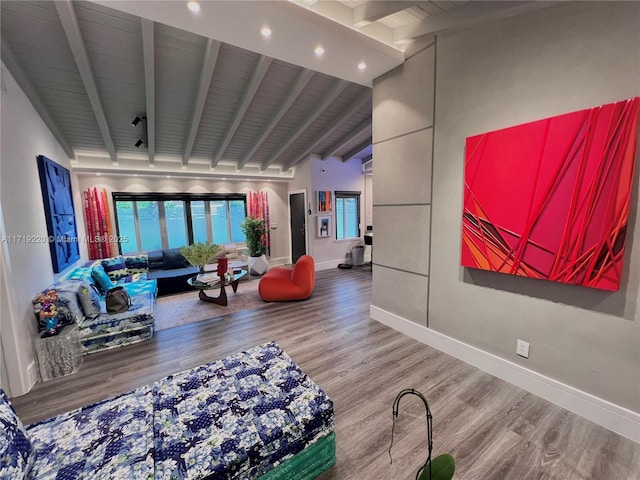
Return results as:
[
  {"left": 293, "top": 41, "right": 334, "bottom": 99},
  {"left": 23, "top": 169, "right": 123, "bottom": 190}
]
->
[{"left": 393, "top": 1, "right": 554, "bottom": 43}]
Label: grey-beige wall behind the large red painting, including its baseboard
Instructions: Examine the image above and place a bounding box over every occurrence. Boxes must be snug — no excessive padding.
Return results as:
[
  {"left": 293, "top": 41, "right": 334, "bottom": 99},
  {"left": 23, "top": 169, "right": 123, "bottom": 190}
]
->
[{"left": 372, "top": 2, "right": 640, "bottom": 441}]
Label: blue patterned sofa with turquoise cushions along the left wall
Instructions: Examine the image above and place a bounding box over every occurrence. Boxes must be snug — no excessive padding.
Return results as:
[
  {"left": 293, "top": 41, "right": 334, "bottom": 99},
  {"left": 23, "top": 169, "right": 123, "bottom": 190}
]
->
[{"left": 33, "top": 255, "right": 157, "bottom": 354}]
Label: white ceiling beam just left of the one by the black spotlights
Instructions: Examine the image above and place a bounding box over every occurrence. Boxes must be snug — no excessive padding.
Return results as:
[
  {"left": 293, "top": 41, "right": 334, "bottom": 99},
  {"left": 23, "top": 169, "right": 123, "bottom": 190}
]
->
[{"left": 54, "top": 0, "right": 118, "bottom": 165}]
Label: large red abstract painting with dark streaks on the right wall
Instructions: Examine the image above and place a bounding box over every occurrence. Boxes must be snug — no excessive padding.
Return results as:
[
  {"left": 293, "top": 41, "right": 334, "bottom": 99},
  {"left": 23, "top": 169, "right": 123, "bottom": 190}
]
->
[{"left": 461, "top": 98, "right": 640, "bottom": 291}]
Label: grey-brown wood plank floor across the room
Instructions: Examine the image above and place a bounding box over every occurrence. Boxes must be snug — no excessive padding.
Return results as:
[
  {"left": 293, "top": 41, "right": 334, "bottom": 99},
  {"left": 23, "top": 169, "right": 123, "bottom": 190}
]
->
[{"left": 12, "top": 268, "right": 640, "bottom": 480}]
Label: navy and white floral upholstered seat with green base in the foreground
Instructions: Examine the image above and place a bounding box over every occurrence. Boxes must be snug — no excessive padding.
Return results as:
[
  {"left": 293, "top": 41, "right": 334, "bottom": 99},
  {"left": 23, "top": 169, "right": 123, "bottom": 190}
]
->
[{"left": 0, "top": 342, "right": 335, "bottom": 480}]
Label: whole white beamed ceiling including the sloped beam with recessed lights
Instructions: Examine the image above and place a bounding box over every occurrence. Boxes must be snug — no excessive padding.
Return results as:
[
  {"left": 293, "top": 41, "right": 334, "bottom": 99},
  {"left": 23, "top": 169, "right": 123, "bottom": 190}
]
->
[{"left": 0, "top": 0, "right": 547, "bottom": 180}]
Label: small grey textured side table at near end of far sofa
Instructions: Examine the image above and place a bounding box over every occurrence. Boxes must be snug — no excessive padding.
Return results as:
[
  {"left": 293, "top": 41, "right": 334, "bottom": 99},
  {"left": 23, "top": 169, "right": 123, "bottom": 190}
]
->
[{"left": 35, "top": 324, "right": 82, "bottom": 382}]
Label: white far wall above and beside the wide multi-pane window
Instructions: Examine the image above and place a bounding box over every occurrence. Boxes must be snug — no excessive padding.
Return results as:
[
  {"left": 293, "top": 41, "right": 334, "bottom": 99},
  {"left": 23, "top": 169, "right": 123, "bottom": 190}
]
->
[{"left": 79, "top": 174, "right": 289, "bottom": 265}]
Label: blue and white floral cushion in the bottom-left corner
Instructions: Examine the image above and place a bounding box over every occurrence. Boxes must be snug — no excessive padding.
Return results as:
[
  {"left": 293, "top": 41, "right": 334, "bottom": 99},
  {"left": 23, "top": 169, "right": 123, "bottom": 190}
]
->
[{"left": 0, "top": 388, "right": 36, "bottom": 478}]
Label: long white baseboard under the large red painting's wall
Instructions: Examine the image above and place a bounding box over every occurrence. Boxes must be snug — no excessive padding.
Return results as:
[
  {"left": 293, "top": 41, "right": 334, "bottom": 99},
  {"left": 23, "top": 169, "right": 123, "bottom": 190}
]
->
[{"left": 369, "top": 305, "right": 640, "bottom": 443}]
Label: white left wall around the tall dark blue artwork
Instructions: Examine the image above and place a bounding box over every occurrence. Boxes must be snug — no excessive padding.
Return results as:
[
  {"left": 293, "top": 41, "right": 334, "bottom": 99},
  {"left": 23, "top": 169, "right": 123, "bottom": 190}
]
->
[{"left": 0, "top": 64, "right": 86, "bottom": 395}]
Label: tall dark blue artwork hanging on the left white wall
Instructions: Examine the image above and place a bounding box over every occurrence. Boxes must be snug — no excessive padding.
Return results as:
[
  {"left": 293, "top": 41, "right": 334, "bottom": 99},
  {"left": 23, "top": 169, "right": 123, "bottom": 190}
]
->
[{"left": 37, "top": 155, "right": 80, "bottom": 273}]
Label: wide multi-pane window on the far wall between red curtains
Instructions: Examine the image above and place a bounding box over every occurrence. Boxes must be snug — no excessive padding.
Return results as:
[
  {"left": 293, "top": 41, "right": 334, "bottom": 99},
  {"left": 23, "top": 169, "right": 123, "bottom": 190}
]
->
[{"left": 113, "top": 193, "right": 246, "bottom": 254}]
